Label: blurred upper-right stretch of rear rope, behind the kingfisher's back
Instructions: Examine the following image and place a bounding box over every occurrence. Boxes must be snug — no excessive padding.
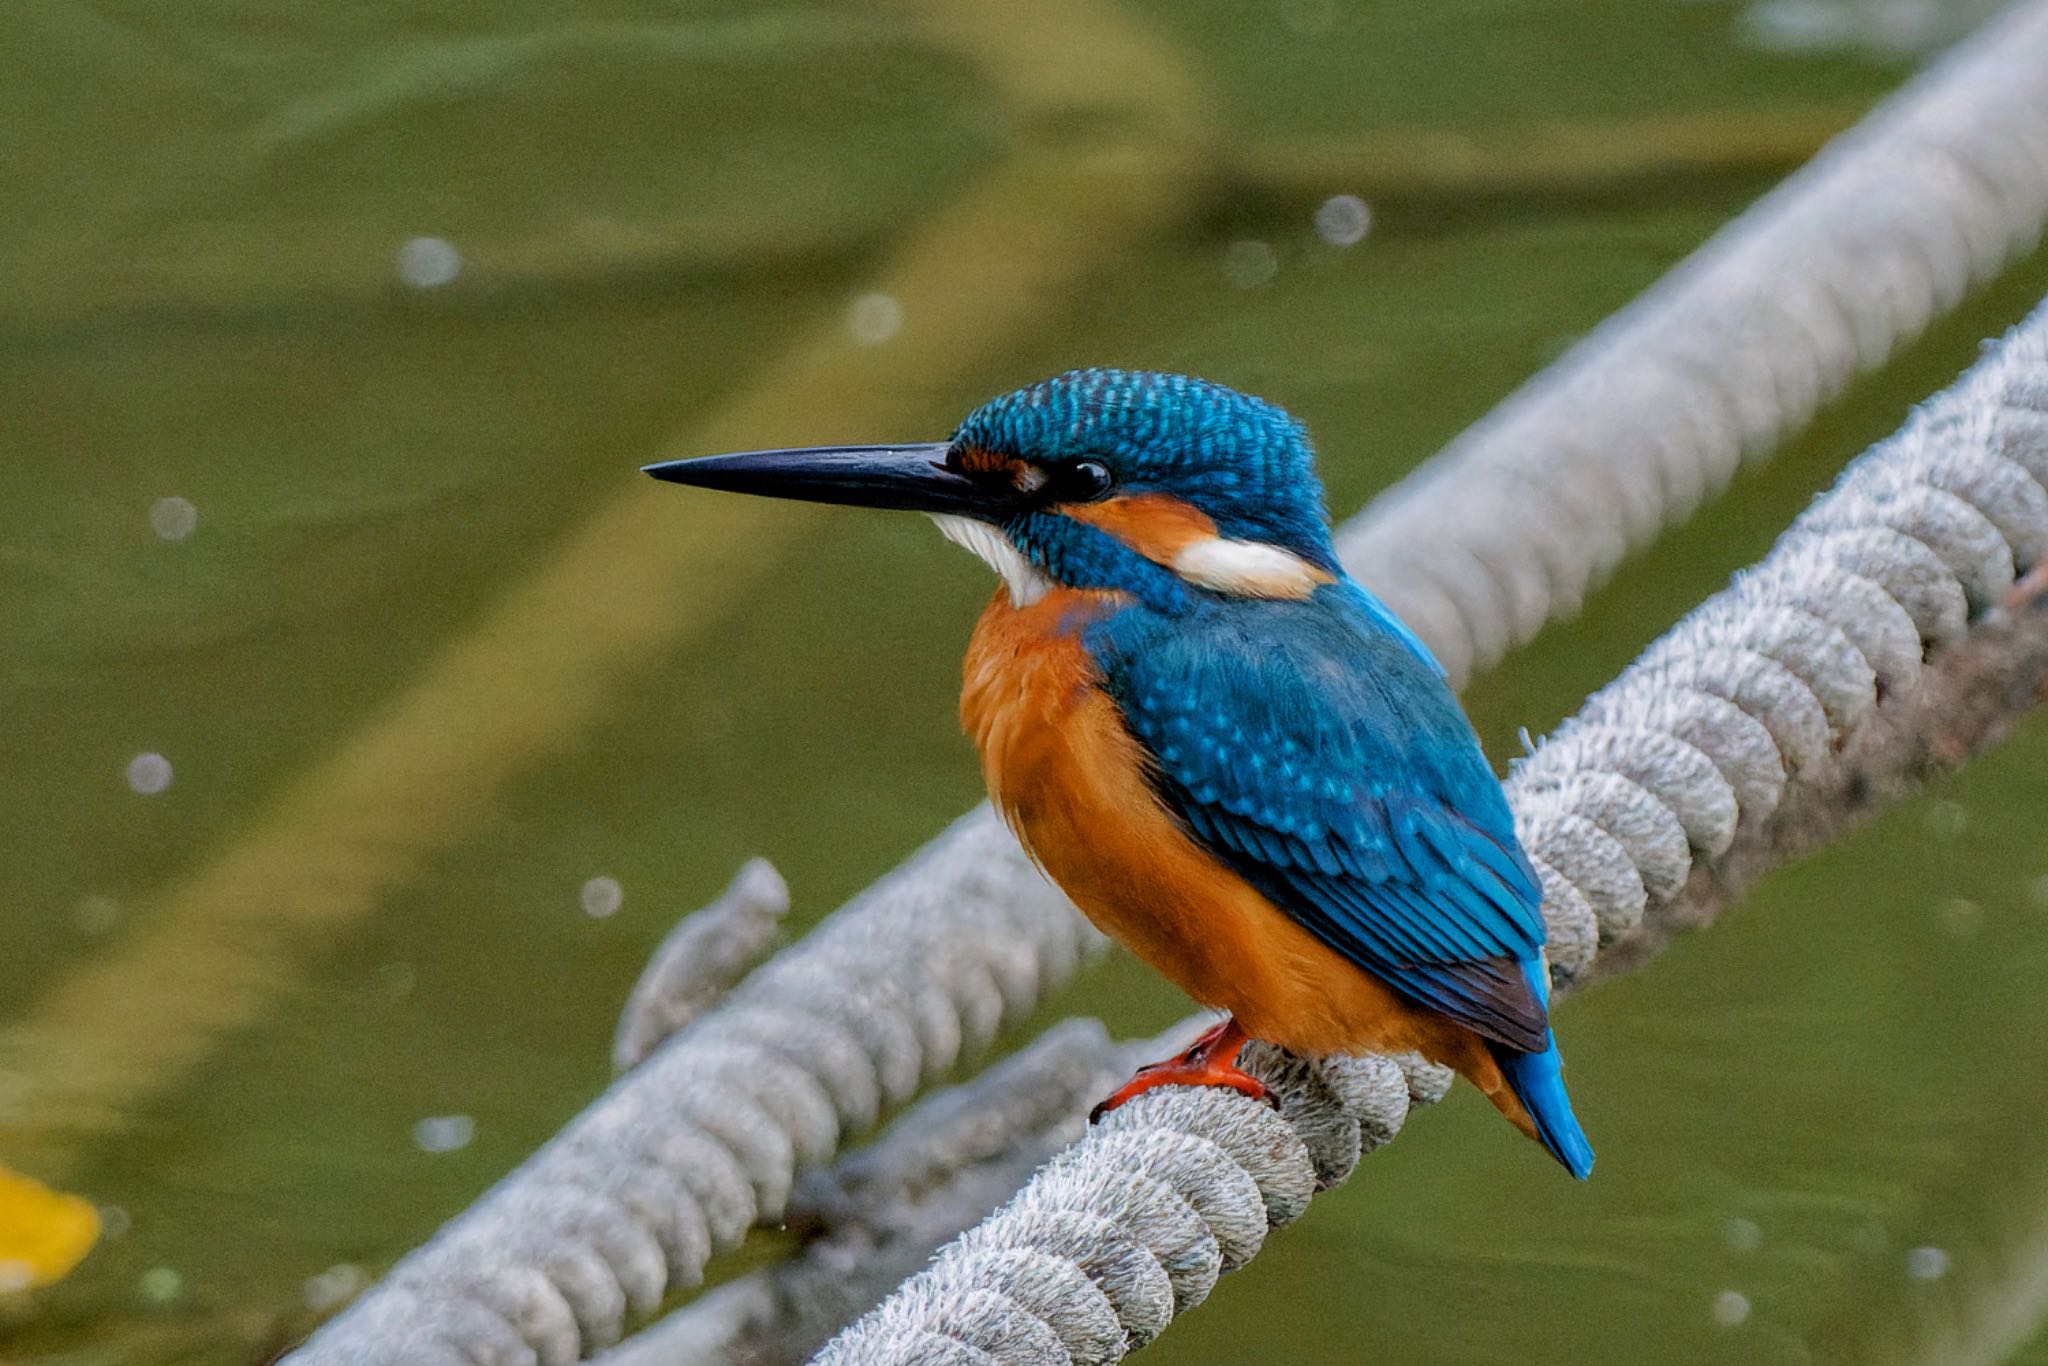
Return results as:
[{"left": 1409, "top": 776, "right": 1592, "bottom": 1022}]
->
[{"left": 1337, "top": 4, "right": 2048, "bottom": 680}]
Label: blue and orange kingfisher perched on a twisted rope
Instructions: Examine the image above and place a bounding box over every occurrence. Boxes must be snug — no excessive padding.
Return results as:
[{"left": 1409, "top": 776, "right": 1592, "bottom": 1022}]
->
[{"left": 647, "top": 369, "right": 1593, "bottom": 1180}]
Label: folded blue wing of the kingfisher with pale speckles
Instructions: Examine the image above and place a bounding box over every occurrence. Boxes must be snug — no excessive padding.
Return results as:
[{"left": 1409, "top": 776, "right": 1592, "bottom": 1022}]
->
[{"left": 1087, "top": 582, "right": 1548, "bottom": 1053}]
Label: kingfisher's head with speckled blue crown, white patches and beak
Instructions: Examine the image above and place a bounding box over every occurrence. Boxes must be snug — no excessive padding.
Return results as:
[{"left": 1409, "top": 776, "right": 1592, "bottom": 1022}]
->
[{"left": 647, "top": 369, "right": 1339, "bottom": 610}]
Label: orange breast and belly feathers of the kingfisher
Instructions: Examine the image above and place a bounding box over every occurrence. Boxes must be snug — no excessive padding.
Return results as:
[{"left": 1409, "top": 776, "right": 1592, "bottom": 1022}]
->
[{"left": 961, "top": 590, "right": 1534, "bottom": 1135}]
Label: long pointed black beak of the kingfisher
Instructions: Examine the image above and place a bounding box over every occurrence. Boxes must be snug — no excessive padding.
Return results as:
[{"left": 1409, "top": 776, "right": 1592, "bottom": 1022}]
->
[{"left": 645, "top": 440, "right": 1010, "bottom": 520}]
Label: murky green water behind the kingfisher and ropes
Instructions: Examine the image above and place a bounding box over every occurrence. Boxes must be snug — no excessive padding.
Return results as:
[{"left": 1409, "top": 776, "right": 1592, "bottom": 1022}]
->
[{"left": 0, "top": 0, "right": 2048, "bottom": 1366}]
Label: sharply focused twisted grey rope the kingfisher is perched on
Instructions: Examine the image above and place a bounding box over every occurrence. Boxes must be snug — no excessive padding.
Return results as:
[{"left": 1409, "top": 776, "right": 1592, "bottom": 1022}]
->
[{"left": 817, "top": 305, "right": 2048, "bottom": 1366}]
